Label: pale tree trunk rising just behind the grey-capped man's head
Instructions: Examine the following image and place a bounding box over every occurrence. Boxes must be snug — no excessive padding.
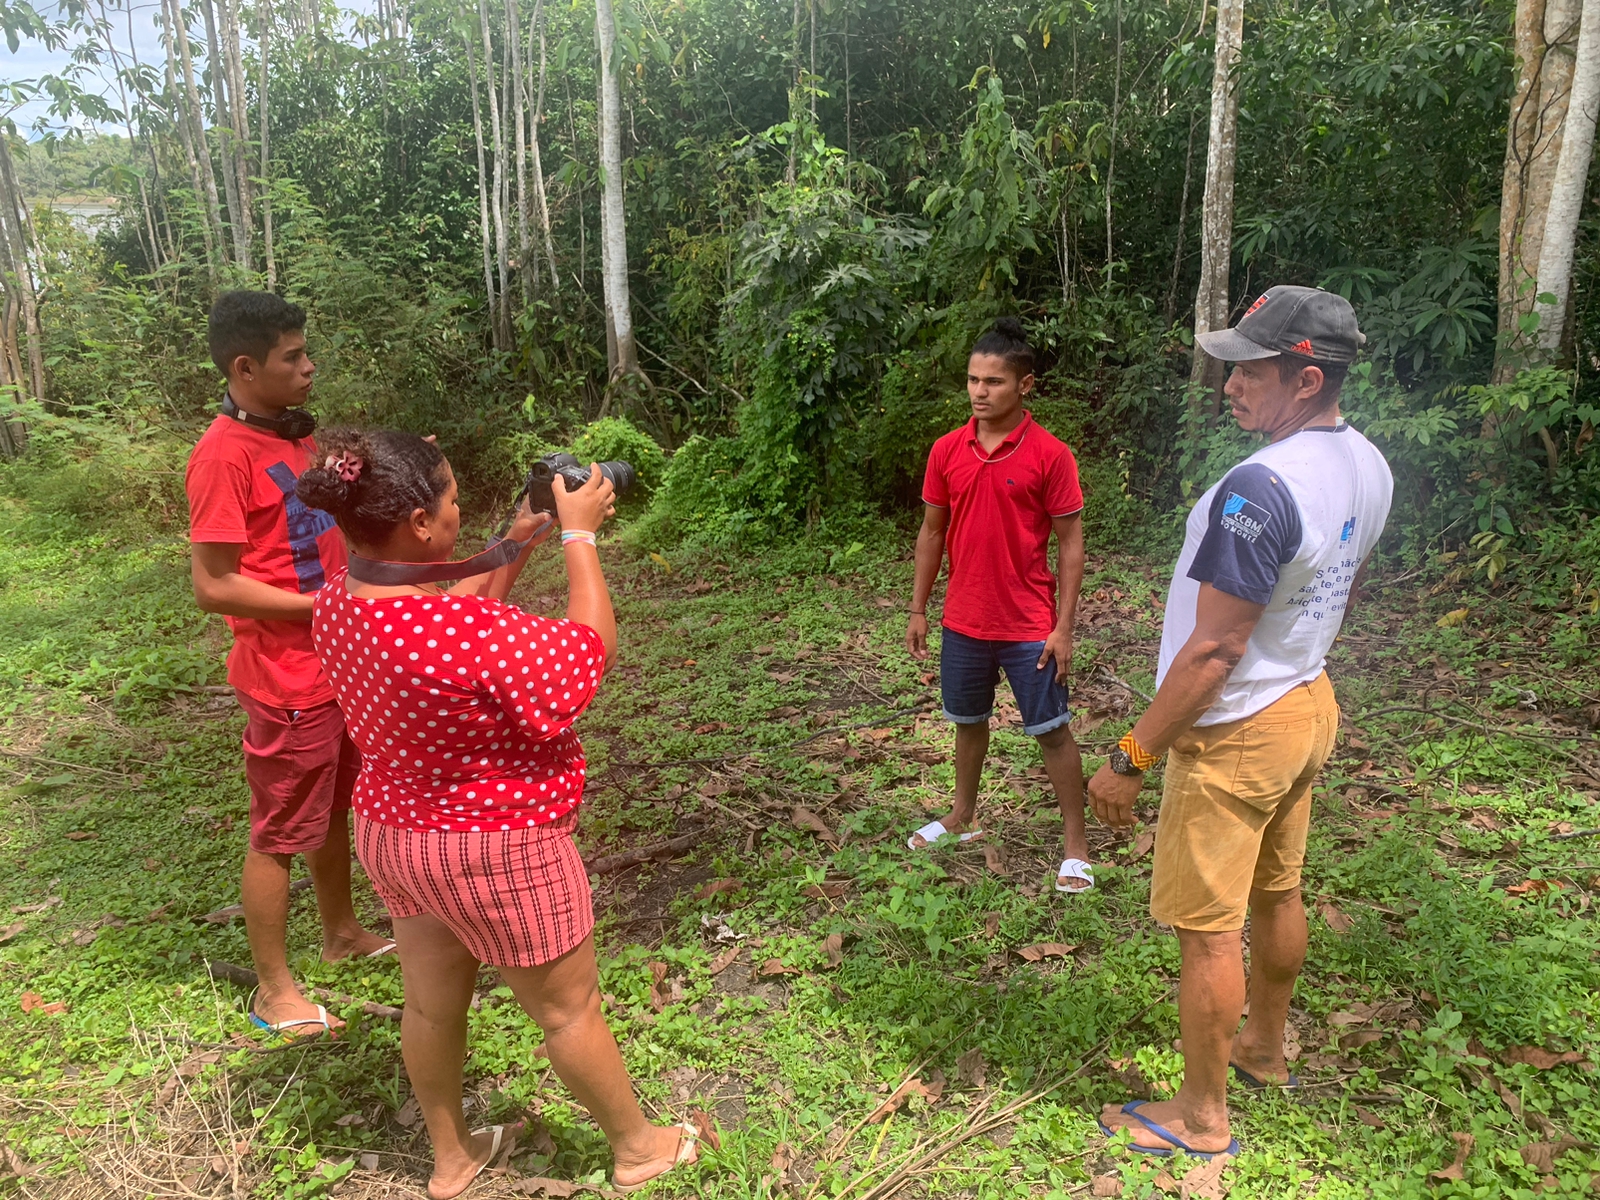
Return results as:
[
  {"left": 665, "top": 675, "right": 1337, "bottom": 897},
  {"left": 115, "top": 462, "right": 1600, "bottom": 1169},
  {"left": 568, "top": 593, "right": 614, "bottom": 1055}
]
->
[{"left": 1189, "top": 0, "right": 1245, "bottom": 416}]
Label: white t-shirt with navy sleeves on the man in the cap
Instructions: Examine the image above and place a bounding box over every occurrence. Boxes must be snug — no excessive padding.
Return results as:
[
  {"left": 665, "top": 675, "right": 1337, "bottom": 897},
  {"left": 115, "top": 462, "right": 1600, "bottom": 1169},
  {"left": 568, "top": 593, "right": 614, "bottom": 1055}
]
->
[{"left": 1155, "top": 424, "right": 1394, "bottom": 725}]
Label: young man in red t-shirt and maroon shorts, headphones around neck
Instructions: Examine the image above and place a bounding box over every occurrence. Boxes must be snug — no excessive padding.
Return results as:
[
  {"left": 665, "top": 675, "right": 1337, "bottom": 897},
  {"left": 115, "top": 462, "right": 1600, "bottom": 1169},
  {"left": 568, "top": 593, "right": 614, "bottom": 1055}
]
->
[{"left": 184, "top": 291, "right": 394, "bottom": 1034}]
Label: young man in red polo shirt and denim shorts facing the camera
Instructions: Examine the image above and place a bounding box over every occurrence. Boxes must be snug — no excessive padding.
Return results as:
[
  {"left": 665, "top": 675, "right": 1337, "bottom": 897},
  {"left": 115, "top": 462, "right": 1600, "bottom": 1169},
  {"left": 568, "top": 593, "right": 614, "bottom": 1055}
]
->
[{"left": 906, "top": 317, "right": 1094, "bottom": 893}]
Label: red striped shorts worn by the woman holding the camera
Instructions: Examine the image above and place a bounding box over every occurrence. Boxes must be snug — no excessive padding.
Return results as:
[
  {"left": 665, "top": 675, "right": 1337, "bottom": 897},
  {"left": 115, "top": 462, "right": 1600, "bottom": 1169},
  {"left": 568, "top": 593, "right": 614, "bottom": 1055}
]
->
[{"left": 355, "top": 808, "right": 595, "bottom": 966}]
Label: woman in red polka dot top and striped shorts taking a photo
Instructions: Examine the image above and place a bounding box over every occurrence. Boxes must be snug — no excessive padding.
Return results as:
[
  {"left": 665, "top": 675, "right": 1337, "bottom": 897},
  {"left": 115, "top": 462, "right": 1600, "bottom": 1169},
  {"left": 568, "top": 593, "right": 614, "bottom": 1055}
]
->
[{"left": 298, "top": 432, "right": 696, "bottom": 1200}]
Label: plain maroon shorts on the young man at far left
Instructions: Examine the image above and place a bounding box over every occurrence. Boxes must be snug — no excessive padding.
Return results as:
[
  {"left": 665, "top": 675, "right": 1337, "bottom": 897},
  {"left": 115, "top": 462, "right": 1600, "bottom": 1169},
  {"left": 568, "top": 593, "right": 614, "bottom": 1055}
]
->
[{"left": 234, "top": 691, "right": 362, "bottom": 854}]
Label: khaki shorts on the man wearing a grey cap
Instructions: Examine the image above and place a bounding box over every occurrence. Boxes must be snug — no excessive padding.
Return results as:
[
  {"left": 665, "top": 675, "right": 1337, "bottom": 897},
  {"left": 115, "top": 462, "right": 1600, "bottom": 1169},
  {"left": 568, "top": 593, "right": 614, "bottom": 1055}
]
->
[{"left": 1150, "top": 674, "right": 1339, "bottom": 933}]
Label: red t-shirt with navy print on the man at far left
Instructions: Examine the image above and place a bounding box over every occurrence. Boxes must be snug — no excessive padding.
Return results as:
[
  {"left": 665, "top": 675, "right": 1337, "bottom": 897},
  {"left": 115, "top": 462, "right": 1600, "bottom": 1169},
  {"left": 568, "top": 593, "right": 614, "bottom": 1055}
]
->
[{"left": 184, "top": 416, "right": 346, "bottom": 709}]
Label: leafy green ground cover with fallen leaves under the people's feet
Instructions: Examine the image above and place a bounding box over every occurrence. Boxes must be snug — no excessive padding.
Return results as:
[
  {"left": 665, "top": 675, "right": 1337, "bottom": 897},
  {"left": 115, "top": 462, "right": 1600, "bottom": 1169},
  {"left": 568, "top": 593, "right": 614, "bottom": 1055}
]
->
[{"left": 0, "top": 501, "right": 1600, "bottom": 1200}]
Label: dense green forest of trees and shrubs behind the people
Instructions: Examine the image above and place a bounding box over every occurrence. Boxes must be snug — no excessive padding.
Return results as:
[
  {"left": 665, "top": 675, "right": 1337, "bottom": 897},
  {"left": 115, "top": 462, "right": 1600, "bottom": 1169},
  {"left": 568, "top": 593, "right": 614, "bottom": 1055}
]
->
[{"left": 3, "top": 0, "right": 1600, "bottom": 588}]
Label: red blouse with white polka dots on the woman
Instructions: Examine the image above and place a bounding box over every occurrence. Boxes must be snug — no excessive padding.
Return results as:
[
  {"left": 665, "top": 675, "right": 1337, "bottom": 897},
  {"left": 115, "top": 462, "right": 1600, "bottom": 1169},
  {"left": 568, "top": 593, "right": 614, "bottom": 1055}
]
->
[{"left": 312, "top": 571, "right": 605, "bottom": 832}]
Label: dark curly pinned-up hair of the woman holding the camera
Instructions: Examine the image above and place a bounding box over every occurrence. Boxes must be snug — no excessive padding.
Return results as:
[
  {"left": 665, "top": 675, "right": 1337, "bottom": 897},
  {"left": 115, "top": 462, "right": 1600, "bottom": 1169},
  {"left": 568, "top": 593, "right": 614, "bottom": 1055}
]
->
[{"left": 294, "top": 429, "right": 450, "bottom": 546}]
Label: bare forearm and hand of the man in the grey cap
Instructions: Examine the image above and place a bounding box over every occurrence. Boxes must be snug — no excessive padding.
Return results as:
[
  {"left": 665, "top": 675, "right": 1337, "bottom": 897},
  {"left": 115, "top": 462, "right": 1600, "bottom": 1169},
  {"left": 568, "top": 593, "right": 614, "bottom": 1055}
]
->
[{"left": 1090, "top": 584, "right": 1267, "bottom": 826}]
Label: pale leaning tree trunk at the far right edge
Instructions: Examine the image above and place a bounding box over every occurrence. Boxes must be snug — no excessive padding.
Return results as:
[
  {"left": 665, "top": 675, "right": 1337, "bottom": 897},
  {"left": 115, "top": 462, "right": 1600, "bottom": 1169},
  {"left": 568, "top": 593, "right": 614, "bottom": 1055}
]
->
[{"left": 1534, "top": 0, "right": 1600, "bottom": 362}]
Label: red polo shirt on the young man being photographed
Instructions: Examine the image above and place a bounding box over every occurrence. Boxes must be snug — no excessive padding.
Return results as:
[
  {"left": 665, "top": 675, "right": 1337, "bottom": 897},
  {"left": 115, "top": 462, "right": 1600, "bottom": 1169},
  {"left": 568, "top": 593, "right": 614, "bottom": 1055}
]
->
[{"left": 922, "top": 410, "right": 1083, "bottom": 642}]
